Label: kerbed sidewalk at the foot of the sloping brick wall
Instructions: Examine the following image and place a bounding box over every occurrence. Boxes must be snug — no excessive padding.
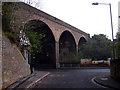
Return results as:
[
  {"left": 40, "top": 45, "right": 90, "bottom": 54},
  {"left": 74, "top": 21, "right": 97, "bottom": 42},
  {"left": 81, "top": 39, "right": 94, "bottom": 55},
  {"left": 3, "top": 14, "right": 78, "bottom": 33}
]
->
[{"left": 6, "top": 71, "right": 50, "bottom": 90}]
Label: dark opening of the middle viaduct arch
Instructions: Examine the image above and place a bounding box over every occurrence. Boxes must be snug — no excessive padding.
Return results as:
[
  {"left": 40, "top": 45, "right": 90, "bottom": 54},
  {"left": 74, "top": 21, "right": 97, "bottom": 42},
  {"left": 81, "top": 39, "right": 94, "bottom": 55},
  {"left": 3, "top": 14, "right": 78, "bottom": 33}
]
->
[{"left": 59, "top": 30, "right": 76, "bottom": 62}]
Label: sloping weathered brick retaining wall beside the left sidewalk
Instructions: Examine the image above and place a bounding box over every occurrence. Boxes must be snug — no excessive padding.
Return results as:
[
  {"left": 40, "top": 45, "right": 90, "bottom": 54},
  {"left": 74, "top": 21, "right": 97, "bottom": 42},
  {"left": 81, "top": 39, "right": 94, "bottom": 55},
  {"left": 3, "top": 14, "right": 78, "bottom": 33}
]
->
[{"left": 2, "top": 35, "right": 30, "bottom": 88}]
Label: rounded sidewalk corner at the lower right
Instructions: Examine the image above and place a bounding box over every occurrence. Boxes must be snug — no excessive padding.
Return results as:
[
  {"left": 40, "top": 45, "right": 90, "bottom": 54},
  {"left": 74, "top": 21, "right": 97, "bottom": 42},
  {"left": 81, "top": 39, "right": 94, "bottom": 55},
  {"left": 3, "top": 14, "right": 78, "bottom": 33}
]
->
[{"left": 94, "top": 76, "right": 120, "bottom": 90}]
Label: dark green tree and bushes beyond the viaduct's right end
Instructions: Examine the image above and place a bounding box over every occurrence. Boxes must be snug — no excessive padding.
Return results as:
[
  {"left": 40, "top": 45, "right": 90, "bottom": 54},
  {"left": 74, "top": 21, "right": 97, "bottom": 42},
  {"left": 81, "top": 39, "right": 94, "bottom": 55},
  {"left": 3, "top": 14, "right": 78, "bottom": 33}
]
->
[{"left": 60, "top": 34, "right": 112, "bottom": 63}]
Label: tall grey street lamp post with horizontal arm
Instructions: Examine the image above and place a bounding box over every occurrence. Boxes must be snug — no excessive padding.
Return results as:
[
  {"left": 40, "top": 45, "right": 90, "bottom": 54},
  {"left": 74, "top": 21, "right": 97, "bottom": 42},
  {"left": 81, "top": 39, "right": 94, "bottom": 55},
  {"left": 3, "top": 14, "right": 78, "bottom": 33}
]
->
[{"left": 92, "top": 2, "right": 116, "bottom": 78}]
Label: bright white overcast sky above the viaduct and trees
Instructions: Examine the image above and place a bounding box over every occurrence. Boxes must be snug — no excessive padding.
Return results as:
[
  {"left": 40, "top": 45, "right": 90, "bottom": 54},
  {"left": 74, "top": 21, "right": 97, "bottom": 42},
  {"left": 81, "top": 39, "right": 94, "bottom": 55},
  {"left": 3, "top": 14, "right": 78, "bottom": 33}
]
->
[{"left": 21, "top": 0, "right": 119, "bottom": 39}]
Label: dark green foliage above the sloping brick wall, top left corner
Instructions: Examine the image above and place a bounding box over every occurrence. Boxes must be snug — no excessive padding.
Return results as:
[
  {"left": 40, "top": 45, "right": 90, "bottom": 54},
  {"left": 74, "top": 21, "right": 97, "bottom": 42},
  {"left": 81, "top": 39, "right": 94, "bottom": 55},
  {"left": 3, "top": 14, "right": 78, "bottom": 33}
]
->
[{"left": 2, "top": 2, "right": 18, "bottom": 32}]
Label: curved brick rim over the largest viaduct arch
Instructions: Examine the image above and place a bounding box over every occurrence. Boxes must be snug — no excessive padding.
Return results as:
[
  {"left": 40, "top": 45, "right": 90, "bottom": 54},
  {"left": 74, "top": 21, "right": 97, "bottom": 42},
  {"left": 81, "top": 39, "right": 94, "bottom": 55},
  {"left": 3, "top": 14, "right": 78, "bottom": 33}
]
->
[{"left": 24, "top": 15, "right": 57, "bottom": 41}]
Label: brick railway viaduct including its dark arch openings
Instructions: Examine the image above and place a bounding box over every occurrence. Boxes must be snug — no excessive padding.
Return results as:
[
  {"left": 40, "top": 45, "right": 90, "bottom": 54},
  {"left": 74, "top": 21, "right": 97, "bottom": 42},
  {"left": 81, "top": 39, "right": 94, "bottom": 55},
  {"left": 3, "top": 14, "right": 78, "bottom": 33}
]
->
[{"left": 16, "top": 2, "right": 88, "bottom": 68}]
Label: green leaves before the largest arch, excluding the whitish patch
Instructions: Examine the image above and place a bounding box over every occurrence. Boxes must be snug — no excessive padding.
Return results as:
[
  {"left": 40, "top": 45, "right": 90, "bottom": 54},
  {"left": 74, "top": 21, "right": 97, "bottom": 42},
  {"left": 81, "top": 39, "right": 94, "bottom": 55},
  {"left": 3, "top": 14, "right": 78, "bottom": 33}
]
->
[{"left": 24, "top": 25, "right": 45, "bottom": 55}]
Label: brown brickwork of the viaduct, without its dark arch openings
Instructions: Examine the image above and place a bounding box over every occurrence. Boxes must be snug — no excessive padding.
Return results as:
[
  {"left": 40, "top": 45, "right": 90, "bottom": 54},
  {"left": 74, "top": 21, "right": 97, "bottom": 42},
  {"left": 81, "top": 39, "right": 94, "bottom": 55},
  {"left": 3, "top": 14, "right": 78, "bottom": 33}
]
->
[{"left": 12, "top": 3, "right": 88, "bottom": 67}]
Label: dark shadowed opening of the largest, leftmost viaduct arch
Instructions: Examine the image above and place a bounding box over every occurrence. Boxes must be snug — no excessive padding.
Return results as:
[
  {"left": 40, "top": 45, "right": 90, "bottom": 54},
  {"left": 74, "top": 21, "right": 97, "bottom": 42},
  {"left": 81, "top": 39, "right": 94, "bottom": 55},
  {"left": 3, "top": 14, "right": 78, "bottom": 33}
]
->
[{"left": 26, "top": 19, "right": 56, "bottom": 68}]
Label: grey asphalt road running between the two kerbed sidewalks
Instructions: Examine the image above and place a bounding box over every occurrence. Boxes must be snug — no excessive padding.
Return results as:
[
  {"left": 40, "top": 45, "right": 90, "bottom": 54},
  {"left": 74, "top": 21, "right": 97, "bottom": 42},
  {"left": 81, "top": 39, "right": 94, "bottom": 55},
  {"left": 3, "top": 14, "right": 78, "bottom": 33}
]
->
[{"left": 34, "top": 68, "right": 110, "bottom": 88}]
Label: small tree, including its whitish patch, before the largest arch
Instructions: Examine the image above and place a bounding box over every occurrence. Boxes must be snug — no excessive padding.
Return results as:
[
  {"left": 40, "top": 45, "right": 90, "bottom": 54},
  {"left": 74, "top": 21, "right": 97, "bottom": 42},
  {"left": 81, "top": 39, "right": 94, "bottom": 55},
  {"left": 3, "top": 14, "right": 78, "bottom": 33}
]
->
[{"left": 21, "top": 22, "right": 45, "bottom": 55}]
